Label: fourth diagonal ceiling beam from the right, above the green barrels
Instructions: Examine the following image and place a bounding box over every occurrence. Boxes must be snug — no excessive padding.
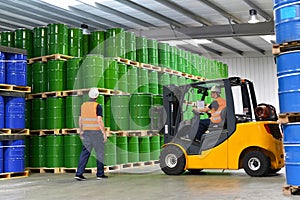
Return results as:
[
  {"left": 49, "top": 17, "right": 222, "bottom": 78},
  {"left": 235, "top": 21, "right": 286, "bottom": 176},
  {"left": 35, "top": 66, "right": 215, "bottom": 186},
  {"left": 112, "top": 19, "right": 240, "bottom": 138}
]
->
[{"left": 116, "top": 0, "right": 187, "bottom": 27}]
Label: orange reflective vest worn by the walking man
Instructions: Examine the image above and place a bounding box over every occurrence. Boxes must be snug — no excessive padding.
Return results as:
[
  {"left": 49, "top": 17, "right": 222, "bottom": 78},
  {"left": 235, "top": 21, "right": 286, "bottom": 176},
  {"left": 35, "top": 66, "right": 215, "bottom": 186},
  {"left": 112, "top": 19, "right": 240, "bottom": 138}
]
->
[{"left": 81, "top": 102, "right": 100, "bottom": 131}]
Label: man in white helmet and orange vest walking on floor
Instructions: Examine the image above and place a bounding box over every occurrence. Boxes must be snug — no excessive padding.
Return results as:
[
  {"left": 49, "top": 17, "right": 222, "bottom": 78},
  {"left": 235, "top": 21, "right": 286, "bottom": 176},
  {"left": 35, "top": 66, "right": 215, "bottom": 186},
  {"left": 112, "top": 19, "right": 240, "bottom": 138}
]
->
[{"left": 74, "top": 88, "right": 107, "bottom": 181}]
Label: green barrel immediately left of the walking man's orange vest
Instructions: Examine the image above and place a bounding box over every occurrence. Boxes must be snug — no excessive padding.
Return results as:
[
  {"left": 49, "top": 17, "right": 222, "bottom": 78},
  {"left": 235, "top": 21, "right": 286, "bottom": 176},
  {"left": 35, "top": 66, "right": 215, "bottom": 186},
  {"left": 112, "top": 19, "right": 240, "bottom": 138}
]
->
[{"left": 65, "top": 96, "right": 82, "bottom": 128}]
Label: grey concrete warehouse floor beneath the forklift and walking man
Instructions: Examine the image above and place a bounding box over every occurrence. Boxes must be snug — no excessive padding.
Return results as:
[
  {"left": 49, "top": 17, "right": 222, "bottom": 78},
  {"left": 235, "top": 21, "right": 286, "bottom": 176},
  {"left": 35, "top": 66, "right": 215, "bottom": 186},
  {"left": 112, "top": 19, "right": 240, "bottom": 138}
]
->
[{"left": 0, "top": 165, "right": 300, "bottom": 200}]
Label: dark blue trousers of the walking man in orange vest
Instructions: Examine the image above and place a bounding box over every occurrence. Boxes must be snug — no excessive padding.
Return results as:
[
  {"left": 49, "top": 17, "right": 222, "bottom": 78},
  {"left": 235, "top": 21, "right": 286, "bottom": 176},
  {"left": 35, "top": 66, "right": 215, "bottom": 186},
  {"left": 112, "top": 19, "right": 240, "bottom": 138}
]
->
[{"left": 76, "top": 131, "right": 104, "bottom": 176}]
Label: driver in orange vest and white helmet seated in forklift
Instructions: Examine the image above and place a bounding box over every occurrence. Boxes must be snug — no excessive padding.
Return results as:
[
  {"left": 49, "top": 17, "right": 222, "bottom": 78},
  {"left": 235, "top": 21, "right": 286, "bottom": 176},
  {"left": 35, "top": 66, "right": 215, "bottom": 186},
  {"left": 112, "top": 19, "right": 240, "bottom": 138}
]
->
[{"left": 193, "top": 86, "right": 226, "bottom": 141}]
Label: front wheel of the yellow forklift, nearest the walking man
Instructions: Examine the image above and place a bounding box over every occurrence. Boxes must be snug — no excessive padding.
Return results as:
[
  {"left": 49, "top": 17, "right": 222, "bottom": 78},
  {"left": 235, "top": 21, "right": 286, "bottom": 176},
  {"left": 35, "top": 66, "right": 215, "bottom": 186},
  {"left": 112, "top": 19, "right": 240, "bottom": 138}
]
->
[{"left": 159, "top": 145, "right": 185, "bottom": 175}]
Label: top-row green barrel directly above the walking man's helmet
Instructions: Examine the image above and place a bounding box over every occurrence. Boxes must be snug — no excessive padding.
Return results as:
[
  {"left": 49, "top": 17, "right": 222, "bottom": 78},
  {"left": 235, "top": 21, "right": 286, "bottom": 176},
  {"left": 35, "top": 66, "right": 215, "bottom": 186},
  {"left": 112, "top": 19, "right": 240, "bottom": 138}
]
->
[{"left": 90, "top": 31, "right": 105, "bottom": 55}]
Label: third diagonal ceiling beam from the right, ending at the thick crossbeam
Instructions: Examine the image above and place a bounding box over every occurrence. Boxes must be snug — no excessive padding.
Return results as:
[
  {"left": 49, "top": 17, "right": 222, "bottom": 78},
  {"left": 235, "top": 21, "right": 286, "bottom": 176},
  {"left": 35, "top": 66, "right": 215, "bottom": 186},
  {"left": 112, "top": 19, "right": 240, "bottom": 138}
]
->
[{"left": 155, "top": 0, "right": 212, "bottom": 26}]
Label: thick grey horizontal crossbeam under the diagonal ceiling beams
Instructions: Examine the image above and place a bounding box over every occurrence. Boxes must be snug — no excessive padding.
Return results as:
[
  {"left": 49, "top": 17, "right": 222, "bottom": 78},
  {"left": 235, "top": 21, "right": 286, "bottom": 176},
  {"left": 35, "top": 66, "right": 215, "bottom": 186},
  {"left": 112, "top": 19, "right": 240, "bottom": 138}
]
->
[{"left": 134, "top": 22, "right": 274, "bottom": 40}]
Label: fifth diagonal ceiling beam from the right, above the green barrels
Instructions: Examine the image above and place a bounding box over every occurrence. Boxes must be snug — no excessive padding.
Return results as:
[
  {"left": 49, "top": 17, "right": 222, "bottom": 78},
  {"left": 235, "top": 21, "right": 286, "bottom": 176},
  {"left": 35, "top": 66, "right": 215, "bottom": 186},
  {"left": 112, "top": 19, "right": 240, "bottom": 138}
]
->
[{"left": 95, "top": 2, "right": 156, "bottom": 27}]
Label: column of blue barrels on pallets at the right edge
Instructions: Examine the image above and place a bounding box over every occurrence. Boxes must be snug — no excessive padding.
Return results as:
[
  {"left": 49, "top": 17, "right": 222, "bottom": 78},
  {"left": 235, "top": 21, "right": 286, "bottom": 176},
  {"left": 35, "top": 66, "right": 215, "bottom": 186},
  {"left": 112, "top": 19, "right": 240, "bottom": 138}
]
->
[{"left": 273, "top": 0, "right": 300, "bottom": 186}]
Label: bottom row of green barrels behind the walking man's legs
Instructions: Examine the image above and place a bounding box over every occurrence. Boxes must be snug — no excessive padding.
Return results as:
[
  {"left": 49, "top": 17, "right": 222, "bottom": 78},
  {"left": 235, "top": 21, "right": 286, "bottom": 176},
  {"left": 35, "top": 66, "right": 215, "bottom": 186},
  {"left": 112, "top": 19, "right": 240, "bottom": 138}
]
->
[{"left": 26, "top": 134, "right": 162, "bottom": 168}]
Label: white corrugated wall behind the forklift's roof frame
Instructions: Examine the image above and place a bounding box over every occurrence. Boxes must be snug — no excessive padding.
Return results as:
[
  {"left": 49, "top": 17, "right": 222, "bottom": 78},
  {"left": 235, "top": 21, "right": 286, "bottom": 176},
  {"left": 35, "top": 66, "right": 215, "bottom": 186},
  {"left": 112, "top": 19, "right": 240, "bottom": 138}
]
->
[{"left": 218, "top": 56, "right": 279, "bottom": 113}]
